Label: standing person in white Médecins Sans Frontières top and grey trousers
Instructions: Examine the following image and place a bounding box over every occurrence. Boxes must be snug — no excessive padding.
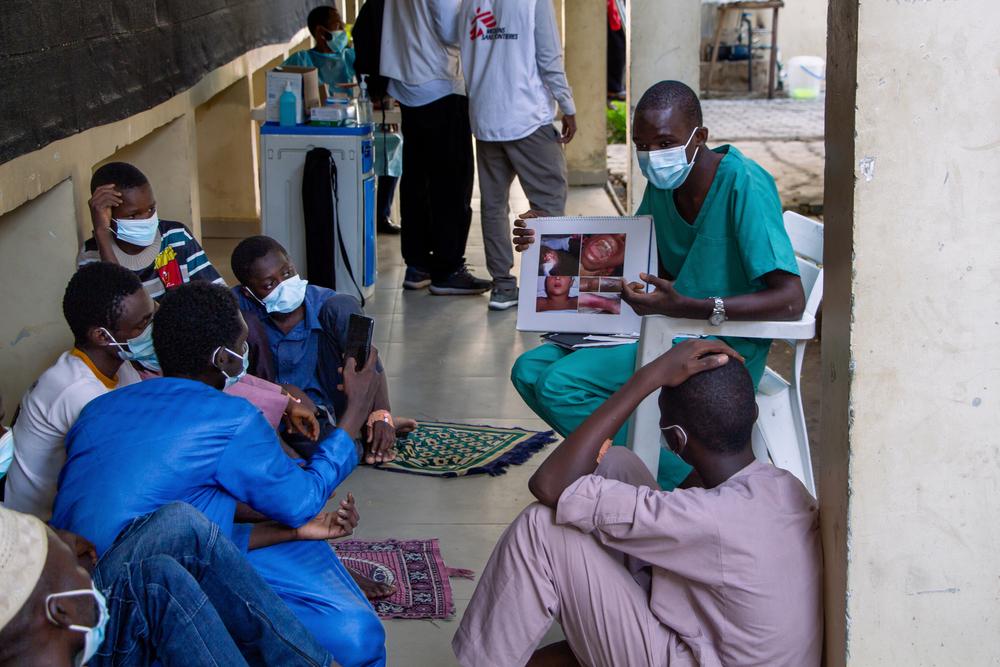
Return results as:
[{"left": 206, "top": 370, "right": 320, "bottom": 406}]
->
[{"left": 457, "top": 0, "right": 576, "bottom": 310}]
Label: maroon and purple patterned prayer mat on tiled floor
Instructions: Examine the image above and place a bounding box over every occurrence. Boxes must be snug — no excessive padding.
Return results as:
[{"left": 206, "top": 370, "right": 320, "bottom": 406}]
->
[{"left": 330, "top": 539, "right": 473, "bottom": 618}]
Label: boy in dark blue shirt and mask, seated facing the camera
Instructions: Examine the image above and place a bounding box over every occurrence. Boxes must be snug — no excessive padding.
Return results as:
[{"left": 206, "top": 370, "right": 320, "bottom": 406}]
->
[{"left": 231, "top": 236, "right": 416, "bottom": 463}]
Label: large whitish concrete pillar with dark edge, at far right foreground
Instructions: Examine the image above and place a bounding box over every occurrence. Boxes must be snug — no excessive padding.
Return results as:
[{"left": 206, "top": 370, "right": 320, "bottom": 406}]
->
[{"left": 817, "top": 0, "right": 1000, "bottom": 667}]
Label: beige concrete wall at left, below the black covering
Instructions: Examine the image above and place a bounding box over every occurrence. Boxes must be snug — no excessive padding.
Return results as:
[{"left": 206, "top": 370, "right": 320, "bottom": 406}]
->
[{"left": 0, "top": 29, "right": 308, "bottom": 416}]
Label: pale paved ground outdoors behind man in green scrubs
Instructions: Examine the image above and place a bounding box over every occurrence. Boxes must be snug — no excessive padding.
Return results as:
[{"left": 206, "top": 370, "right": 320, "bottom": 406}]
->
[{"left": 608, "top": 99, "right": 825, "bottom": 215}]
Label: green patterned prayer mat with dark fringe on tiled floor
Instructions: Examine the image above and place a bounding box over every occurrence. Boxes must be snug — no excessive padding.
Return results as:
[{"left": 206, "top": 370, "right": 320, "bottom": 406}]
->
[{"left": 378, "top": 422, "right": 556, "bottom": 477}]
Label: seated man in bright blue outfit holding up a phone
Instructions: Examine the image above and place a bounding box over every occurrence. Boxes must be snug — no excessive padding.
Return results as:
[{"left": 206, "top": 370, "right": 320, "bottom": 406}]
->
[{"left": 52, "top": 282, "right": 385, "bottom": 667}]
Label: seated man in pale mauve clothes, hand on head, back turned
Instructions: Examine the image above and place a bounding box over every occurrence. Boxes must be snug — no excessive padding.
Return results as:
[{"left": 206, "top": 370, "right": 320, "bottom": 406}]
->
[{"left": 452, "top": 340, "right": 823, "bottom": 667}]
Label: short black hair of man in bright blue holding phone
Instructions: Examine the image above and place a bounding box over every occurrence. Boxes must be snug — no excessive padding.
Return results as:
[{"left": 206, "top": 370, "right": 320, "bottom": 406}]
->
[{"left": 153, "top": 281, "right": 242, "bottom": 377}]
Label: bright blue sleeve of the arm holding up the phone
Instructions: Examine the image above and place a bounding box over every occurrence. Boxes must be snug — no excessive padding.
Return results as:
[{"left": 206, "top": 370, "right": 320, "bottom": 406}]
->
[{"left": 215, "top": 410, "right": 358, "bottom": 528}]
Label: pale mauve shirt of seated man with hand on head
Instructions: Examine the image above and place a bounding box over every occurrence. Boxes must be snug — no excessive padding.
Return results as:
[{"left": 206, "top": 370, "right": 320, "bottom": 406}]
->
[{"left": 556, "top": 461, "right": 823, "bottom": 667}]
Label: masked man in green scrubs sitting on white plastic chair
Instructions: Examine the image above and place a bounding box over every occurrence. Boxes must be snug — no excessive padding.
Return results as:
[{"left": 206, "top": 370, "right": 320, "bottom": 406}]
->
[{"left": 511, "top": 81, "right": 805, "bottom": 489}]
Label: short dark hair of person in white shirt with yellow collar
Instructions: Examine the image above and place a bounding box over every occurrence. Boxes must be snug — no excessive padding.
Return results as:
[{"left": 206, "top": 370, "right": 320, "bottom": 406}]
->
[{"left": 63, "top": 262, "right": 142, "bottom": 346}]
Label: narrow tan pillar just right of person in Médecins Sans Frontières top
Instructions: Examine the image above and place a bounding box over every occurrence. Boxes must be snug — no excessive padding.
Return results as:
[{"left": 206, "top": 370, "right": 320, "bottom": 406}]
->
[{"left": 564, "top": 0, "right": 608, "bottom": 185}]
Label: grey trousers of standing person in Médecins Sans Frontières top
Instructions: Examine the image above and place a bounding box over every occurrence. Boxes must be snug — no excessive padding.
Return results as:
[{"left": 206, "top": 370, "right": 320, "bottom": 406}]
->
[{"left": 476, "top": 125, "right": 568, "bottom": 289}]
